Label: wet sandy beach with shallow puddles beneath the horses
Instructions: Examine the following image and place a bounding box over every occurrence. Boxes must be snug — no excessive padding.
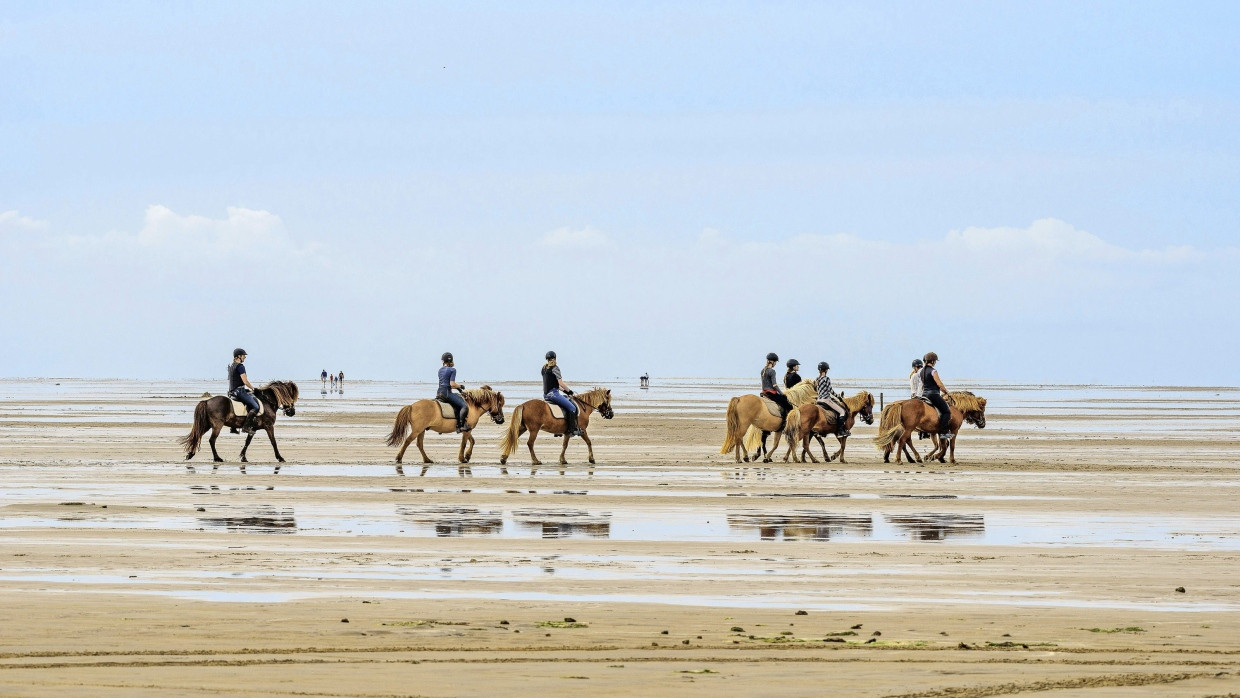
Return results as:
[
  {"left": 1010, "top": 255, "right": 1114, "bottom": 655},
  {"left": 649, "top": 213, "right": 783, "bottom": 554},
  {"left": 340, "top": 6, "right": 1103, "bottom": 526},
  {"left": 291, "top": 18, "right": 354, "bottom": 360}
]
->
[{"left": 0, "top": 379, "right": 1240, "bottom": 697}]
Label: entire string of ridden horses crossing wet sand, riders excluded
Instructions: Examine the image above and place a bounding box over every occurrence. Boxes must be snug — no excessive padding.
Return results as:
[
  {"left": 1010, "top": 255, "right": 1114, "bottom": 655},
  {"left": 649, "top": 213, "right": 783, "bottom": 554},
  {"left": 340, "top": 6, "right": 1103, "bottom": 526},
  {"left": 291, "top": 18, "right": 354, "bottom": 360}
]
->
[{"left": 180, "top": 381, "right": 986, "bottom": 467}]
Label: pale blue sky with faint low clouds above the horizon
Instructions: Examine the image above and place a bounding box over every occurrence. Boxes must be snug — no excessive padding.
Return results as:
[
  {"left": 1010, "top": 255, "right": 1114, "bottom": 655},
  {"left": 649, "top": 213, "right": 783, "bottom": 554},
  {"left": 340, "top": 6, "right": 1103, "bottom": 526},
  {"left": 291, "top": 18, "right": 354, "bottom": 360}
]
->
[{"left": 0, "top": 2, "right": 1240, "bottom": 384}]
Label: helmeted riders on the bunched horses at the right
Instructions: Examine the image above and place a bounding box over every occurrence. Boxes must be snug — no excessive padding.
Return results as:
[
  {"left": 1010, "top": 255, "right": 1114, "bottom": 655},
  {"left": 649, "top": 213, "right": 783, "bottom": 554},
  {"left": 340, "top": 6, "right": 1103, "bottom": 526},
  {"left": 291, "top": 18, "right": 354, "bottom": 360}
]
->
[{"left": 760, "top": 352, "right": 951, "bottom": 440}]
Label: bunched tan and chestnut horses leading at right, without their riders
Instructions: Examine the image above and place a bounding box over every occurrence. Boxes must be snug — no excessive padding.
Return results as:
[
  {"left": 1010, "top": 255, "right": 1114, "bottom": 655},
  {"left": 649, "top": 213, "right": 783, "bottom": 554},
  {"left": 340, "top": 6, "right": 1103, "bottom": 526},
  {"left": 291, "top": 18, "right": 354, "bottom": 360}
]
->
[{"left": 719, "top": 381, "right": 986, "bottom": 462}]
